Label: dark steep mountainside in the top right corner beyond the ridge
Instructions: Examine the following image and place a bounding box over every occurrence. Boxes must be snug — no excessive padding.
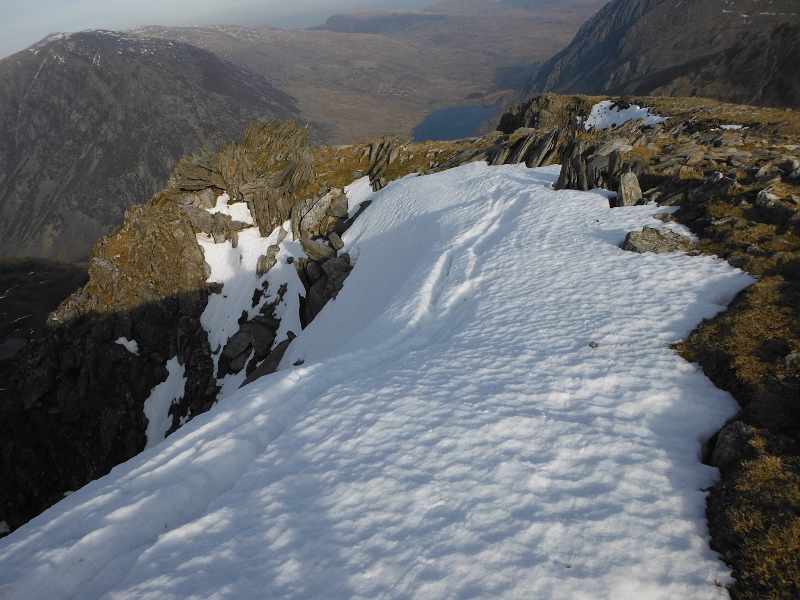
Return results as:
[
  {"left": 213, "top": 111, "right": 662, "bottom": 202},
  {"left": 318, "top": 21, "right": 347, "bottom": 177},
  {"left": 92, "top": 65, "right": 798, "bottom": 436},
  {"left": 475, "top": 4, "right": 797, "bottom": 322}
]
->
[{"left": 527, "top": 0, "right": 800, "bottom": 107}]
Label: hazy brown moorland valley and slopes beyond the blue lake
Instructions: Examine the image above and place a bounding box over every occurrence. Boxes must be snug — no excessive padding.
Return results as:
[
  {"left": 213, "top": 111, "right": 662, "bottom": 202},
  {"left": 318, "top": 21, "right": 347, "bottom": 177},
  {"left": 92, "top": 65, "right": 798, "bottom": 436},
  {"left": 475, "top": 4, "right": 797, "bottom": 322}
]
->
[{"left": 134, "top": 0, "right": 594, "bottom": 143}]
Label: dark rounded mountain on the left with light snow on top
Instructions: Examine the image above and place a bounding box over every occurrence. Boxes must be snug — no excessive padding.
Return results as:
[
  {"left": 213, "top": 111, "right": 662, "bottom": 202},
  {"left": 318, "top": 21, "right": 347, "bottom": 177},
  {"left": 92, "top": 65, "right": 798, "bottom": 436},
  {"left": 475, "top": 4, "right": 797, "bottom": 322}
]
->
[{"left": 0, "top": 31, "right": 298, "bottom": 261}]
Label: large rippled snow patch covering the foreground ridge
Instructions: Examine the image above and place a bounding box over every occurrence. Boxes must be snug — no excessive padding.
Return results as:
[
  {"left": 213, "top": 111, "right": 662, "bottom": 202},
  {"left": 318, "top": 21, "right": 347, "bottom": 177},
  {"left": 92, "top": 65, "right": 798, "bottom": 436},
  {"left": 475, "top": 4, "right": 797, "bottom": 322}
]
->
[{"left": 0, "top": 164, "right": 751, "bottom": 599}]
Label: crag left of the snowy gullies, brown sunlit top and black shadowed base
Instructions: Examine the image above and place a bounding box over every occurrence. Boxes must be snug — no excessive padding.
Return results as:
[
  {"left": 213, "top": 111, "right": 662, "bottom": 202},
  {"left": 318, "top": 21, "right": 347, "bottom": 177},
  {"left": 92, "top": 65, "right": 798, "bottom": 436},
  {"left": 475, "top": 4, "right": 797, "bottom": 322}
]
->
[{"left": 0, "top": 203, "right": 216, "bottom": 528}]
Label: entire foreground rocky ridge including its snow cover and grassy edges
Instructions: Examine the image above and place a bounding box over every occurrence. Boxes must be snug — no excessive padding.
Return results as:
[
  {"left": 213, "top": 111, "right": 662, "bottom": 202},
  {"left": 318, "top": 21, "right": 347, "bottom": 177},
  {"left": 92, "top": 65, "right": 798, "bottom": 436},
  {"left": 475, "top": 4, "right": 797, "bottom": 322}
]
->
[{"left": 0, "top": 97, "right": 800, "bottom": 598}]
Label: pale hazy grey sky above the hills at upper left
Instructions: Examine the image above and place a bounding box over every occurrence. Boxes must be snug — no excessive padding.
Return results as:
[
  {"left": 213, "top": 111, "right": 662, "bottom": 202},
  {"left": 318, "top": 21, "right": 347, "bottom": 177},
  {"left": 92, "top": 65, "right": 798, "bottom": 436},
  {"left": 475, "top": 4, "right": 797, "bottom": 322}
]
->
[{"left": 0, "top": 0, "right": 433, "bottom": 58}]
